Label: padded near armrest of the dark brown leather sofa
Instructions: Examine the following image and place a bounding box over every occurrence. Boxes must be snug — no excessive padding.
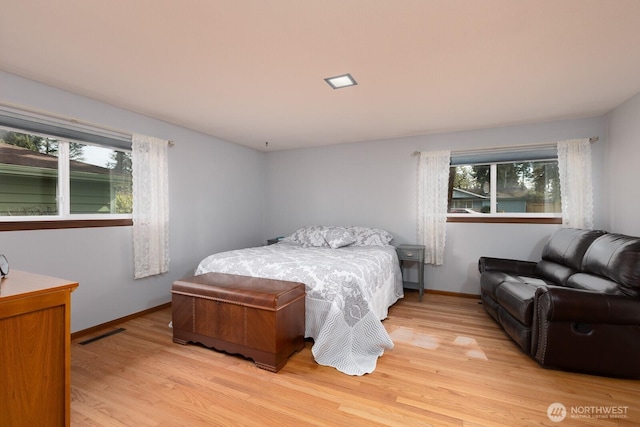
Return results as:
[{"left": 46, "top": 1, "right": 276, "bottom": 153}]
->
[{"left": 535, "top": 286, "right": 640, "bottom": 325}]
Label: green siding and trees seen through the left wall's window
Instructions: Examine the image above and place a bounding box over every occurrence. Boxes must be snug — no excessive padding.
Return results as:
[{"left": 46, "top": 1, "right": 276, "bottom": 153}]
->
[{"left": 0, "top": 129, "right": 133, "bottom": 216}]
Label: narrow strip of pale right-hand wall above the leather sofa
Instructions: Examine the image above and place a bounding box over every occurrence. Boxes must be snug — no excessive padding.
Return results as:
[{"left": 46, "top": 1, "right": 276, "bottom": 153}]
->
[{"left": 606, "top": 93, "right": 640, "bottom": 236}]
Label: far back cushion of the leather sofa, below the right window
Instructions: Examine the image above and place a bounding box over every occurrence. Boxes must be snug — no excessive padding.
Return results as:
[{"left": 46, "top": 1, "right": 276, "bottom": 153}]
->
[{"left": 536, "top": 228, "right": 605, "bottom": 286}]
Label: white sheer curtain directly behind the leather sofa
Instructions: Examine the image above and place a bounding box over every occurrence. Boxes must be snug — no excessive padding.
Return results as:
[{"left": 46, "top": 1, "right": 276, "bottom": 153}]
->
[{"left": 558, "top": 139, "right": 593, "bottom": 229}]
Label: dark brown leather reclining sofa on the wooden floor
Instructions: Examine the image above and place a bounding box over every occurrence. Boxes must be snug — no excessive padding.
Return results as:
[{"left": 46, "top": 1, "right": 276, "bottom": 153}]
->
[{"left": 478, "top": 228, "right": 640, "bottom": 378}]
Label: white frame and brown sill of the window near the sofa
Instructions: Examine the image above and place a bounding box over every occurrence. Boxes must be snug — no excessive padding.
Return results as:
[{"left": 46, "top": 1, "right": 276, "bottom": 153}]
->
[{"left": 447, "top": 154, "right": 562, "bottom": 224}]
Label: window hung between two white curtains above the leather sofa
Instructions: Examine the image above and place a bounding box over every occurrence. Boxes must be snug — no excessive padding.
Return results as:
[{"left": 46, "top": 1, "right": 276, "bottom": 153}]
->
[{"left": 448, "top": 146, "right": 562, "bottom": 222}]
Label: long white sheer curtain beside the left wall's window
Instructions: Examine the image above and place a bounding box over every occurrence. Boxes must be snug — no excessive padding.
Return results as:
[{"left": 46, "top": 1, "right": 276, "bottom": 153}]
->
[{"left": 131, "top": 134, "right": 169, "bottom": 279}]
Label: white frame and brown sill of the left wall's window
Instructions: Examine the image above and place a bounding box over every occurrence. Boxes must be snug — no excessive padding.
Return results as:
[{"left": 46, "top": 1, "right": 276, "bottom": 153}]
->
[{"left": 0, "top": 124, "right": 133, "bottom": 231}]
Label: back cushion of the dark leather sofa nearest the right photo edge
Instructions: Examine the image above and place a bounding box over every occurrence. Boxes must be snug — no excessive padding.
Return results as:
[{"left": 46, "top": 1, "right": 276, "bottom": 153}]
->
[{"left": 582, "top": 233, "right": 640, "bottom": 297}]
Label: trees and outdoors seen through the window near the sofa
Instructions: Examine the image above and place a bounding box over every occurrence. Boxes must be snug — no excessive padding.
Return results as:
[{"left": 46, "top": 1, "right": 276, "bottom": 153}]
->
[{"left": 449, "top": 160, "right": 561, "bottom": 213}]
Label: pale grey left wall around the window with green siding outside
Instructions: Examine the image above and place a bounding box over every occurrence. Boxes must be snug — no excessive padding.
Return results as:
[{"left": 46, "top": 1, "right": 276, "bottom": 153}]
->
[{"left": 0, "top": 72, "right": 265, "bottom": 331}]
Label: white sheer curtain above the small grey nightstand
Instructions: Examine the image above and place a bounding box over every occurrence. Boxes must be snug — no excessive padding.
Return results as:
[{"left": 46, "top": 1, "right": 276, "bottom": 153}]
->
[{"left": 417, "top": 151, "right": 451, "bottom": 265}]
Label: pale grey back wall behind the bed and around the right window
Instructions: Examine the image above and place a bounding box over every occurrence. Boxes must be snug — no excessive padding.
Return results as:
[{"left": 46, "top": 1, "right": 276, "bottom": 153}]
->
[{"left": 265, "top": 117, "right": 608, "bottom": 294}]
